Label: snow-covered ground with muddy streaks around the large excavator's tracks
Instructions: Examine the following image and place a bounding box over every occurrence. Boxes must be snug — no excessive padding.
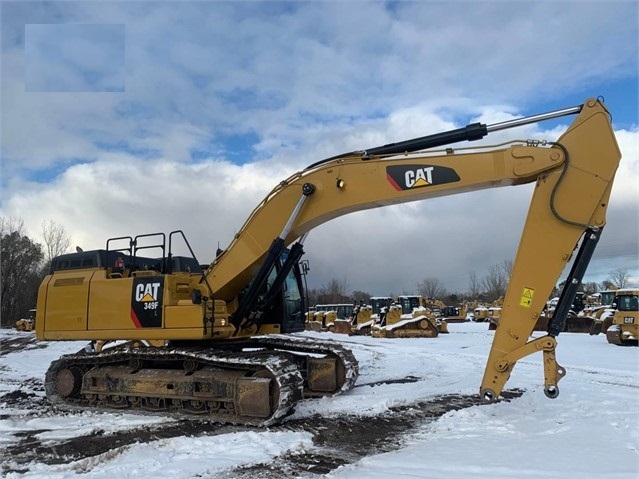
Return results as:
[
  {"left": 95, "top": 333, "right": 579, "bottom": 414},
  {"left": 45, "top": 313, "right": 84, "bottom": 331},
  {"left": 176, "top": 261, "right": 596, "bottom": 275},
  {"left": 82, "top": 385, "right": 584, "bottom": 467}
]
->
[{"left": 0, "top": 323, "right": 639, "bottom": 479}]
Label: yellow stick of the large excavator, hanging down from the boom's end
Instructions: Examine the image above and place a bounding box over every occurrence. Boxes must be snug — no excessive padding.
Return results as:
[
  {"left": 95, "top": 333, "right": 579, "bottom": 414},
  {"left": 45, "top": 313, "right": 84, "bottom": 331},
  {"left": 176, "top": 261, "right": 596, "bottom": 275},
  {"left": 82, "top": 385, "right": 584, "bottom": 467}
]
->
[{"left": 480, "top": 100, "right": 621, "bottom": 402}]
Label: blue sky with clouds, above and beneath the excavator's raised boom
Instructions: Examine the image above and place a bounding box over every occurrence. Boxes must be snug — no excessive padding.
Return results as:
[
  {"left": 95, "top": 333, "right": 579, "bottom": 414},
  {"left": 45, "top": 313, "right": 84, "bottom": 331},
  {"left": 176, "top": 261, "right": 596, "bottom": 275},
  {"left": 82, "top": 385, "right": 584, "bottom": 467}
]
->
[{"left": 0, "top": 1, "right": 639, "bottom": 295}]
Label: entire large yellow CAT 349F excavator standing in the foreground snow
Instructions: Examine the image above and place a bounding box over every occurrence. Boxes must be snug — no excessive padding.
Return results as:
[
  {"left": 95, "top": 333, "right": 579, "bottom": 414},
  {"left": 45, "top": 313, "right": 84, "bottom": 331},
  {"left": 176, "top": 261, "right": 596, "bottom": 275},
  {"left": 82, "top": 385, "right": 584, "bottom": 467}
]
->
[{"left": 36, "top": 99, "right": 621, "bottom": 425}]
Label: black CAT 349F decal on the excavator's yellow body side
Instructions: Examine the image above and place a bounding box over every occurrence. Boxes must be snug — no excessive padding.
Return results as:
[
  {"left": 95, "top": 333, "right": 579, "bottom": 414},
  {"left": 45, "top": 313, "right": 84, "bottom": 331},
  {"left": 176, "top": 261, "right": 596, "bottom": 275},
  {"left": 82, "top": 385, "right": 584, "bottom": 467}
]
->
[{"left": 131, "top": 276, "right": 164, "bottom": 328}]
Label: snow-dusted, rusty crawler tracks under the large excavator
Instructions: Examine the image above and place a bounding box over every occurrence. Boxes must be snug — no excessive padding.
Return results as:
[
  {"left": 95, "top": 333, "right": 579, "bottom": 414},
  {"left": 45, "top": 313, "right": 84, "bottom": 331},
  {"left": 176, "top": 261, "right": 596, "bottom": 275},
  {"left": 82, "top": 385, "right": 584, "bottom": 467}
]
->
[{"left": 45, "top": 335, "right": 358, "bottom": 426}]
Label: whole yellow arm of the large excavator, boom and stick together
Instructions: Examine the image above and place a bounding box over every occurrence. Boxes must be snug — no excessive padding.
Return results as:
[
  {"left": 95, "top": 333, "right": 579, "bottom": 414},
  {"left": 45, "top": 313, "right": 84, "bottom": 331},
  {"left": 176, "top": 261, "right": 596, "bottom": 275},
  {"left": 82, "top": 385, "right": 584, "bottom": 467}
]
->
[{"left": 208, "top": 99, "right": 621, "bottom": 401}]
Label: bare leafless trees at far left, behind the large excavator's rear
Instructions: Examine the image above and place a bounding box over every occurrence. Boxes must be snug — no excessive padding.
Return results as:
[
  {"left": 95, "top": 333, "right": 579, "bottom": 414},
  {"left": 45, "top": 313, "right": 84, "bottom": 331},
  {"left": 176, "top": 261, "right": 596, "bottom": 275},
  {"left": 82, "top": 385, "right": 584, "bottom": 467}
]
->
[{"left": 0, "top": 217, "right": 71, "bottom": 328}]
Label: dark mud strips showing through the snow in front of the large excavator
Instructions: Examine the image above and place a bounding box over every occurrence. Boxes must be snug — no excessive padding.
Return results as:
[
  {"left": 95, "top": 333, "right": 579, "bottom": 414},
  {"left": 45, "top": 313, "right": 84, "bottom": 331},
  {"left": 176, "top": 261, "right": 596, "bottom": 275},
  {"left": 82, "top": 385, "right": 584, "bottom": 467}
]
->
[{"left": 0, "top": 378, "right": 523, "bottom": 479}]
